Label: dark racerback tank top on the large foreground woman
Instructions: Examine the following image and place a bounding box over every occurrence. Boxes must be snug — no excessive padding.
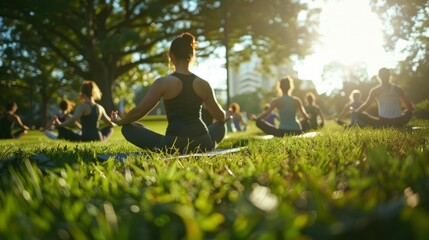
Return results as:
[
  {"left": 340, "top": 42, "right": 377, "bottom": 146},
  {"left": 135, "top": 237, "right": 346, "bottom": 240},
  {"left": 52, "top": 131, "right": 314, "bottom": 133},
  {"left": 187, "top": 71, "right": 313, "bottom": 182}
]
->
[{"left": 164, "top": 73, "right": 208, "bottom": 137}]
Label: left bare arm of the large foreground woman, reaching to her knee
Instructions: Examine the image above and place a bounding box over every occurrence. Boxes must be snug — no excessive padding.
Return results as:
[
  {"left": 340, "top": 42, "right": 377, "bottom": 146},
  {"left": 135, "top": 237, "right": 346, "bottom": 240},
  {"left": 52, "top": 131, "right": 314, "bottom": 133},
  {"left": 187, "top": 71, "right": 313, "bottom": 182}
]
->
[{"left": 111, "top": 78, "right": 168, "bottom": 126}]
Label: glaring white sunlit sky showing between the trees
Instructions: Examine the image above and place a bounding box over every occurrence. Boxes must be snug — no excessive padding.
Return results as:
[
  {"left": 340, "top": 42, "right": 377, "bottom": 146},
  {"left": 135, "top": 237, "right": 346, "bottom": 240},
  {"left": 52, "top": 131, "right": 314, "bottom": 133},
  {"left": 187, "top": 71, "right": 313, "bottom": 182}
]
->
[{"left": 193, "top": 0, "right": 405, "bottom": 94}]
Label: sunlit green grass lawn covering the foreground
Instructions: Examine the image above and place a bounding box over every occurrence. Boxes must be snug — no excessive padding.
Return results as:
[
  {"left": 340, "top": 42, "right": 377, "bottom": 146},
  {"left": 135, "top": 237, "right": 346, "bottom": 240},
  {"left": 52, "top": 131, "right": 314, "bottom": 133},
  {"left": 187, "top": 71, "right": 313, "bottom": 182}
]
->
[{"left": 0, "top": 121, "right": 429, "bottom": 239}]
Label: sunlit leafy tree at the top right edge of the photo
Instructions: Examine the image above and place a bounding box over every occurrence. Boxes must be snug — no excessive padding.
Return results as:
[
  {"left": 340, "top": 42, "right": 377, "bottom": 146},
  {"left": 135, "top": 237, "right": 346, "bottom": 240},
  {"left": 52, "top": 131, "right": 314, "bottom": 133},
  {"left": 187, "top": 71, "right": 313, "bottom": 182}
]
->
[{"left": 372, "top": 0, "right": 429, "bottom": 102}]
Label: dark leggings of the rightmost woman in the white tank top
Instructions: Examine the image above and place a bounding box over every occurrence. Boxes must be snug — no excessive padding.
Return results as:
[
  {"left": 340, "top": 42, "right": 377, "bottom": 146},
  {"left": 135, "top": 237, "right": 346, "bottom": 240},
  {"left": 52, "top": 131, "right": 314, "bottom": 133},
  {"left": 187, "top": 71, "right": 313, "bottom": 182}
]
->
[{"left": 358, "top": 111, "right": 412, "bottom": 128}]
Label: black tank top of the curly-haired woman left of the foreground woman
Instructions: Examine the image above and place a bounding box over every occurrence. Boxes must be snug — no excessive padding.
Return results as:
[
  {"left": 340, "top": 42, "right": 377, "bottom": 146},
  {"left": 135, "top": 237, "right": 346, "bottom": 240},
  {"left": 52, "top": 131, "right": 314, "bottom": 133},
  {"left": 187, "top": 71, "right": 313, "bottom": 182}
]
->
[{"left": 80, "top": 104, "right": 101, "bottom": 141}]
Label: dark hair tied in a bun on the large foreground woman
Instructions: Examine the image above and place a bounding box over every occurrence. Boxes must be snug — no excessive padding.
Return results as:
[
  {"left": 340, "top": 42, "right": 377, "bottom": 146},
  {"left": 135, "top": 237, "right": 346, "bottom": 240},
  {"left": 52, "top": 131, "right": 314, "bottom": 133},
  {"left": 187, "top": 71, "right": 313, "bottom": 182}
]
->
[{"left": 170, "top": 32, "right": 196, "bottom": 62}]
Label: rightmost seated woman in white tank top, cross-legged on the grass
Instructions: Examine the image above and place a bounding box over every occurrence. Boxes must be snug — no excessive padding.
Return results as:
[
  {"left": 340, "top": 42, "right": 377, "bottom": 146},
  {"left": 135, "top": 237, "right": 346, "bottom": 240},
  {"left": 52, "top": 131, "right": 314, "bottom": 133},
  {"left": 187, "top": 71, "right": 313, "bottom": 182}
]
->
[{"left": 356, "top": 68, "right": 414, "bottom": 128}]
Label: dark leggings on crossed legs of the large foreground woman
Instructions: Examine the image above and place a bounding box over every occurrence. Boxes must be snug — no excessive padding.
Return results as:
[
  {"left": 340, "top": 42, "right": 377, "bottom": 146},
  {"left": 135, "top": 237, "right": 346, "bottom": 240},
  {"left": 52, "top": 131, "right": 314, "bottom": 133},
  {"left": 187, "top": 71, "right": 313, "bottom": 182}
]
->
[{"left": 122, "top": 122, "right": 226, "bottom": 153}]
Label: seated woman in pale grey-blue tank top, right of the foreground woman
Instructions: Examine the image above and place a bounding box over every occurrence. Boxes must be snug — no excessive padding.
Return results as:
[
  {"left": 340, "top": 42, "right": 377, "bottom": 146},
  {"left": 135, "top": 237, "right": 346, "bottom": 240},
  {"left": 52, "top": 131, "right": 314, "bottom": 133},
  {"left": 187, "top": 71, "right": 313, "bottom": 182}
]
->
[{"left": 252, "top": 77, "right": 310, "bottom": 137}]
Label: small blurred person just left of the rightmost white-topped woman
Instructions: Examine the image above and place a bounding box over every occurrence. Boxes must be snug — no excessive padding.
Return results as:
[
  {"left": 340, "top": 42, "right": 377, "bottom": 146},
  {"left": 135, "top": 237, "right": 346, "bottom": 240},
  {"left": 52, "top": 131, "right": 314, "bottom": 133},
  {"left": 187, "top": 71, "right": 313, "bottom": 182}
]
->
[{"left": 336, "top": 89, "right": 365, "bottom": 127}]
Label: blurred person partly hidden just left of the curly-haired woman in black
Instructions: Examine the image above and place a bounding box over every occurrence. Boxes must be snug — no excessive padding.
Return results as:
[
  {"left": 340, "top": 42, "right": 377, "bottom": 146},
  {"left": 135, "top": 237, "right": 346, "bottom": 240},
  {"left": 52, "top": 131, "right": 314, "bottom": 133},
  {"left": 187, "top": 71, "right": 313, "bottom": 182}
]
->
[{"left": 42, "top": 99, "right": 82, "bottom": 139}]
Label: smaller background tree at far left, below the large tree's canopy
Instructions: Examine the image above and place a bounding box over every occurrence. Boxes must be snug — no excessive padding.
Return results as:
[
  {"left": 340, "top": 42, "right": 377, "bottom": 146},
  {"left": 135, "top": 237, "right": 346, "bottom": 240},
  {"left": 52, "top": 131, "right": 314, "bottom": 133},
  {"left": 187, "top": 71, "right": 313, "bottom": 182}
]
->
[{"left": 0, "top": 20, "right": 76, "bottom": 125}]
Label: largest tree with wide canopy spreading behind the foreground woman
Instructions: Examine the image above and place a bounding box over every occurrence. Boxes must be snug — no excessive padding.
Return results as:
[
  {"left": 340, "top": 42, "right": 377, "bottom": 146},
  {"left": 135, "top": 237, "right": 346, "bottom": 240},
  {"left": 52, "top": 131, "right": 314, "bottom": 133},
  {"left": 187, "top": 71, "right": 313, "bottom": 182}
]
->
[{"left": 0, "top": 0, "right": 317, "bottom": 111}]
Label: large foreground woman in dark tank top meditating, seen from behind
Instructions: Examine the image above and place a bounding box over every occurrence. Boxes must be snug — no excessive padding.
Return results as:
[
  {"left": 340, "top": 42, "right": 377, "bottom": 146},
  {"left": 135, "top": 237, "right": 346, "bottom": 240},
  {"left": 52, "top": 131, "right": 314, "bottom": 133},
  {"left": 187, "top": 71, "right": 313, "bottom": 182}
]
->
[{"left": 111, "top": 33, "right": 226, "bottom": 153}]
